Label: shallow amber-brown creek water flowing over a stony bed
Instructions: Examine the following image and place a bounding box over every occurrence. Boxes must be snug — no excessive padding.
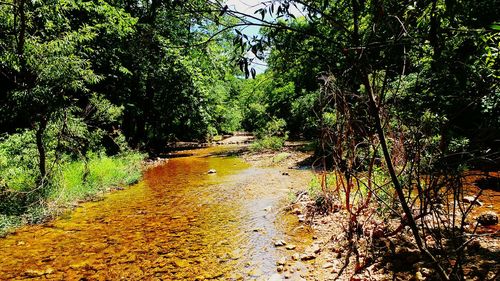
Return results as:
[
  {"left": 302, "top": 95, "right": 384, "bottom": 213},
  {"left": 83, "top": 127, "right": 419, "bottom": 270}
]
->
[{"left": 0, "top": 147, "right": 311, "bottom": 280}]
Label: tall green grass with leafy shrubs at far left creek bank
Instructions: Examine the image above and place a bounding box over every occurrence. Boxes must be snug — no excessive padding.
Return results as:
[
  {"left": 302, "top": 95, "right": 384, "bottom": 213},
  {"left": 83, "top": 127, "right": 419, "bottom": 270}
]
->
[{"left": 0, "top": 130, "right": 144, "bottom": 236}]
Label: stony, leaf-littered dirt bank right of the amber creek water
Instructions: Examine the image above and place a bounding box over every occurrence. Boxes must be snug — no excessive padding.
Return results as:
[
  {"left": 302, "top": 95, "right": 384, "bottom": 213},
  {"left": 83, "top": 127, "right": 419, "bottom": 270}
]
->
[{"left": 242, "top": 145, "right": 500, "bottom": 280}]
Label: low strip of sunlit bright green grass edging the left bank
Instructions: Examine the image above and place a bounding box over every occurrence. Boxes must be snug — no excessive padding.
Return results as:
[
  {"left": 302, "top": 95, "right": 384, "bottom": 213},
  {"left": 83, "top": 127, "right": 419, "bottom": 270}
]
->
[{"left": 0, "top": 152, "right": 144, "bottom": 236}]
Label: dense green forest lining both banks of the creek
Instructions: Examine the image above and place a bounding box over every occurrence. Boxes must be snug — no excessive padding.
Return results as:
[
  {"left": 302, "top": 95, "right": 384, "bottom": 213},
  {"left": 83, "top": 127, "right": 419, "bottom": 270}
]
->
[{"left": 0, "top": 0, "right": 500, "bottom": 280}]
